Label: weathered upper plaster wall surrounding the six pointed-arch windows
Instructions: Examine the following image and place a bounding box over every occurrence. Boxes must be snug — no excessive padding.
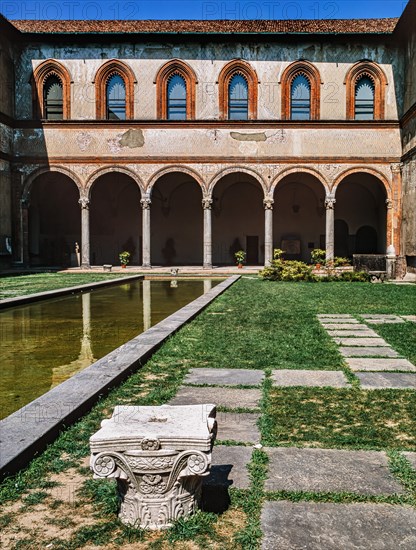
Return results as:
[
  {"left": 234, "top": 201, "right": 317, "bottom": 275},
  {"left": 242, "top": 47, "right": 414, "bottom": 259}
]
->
[{"left": 16, "top": 37, "right": 403, "bottom": 120}]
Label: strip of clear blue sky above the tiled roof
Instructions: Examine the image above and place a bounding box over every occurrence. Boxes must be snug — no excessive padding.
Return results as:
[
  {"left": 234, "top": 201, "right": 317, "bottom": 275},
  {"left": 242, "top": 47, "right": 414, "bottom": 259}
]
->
[{"left": 0, "top": 0, "right": 407, "bottom": 19}]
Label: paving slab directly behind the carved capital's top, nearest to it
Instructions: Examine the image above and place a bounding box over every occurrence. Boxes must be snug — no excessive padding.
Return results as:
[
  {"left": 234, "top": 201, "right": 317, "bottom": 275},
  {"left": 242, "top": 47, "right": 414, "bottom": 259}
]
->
[{"left": 169, "top": 388, "right": 260, "bottom": 409}]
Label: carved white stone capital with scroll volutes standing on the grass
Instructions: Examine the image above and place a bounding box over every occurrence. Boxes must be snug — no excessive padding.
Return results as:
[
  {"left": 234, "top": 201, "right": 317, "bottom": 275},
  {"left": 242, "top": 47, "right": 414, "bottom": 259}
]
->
[{"left": 90, "top": 404, "right": 216, "bottom": 529}]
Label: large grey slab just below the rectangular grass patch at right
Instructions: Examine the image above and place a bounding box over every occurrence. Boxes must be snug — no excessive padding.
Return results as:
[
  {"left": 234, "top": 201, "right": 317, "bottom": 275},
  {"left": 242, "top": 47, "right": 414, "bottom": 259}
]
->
[{"left": 265, "top": 447, "right": 404, "bottom": 495}]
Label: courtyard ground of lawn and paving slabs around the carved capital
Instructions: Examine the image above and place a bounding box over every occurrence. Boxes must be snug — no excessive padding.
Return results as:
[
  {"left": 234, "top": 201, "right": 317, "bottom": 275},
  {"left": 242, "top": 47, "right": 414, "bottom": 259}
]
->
[{"left": 0, "top": 278, "right": 416, "bottom": 550}]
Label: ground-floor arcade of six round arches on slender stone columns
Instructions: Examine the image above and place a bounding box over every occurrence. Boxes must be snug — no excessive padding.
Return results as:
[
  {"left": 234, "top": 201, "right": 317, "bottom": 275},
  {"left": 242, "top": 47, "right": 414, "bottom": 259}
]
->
[{"left": 22, "top": 167, "right": 397, "bottom": 268}]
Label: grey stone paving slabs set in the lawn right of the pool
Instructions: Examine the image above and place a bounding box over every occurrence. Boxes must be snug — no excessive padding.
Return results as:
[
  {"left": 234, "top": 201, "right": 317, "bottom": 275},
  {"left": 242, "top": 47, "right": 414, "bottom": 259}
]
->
[{"left": 170, "top": 322, "right": 416, "bottom": 550}]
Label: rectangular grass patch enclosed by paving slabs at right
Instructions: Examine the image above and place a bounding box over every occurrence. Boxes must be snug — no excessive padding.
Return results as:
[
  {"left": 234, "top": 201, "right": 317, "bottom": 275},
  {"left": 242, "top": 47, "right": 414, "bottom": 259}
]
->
[{"left": 263, "top": 388, "right": 416, "bottom": 450}]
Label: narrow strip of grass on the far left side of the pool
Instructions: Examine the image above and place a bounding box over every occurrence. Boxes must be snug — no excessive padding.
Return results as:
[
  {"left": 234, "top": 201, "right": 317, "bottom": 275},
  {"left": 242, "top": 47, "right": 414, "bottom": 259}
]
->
[{"left": 0, "top": 273, "right": 133, "bottom": 300}]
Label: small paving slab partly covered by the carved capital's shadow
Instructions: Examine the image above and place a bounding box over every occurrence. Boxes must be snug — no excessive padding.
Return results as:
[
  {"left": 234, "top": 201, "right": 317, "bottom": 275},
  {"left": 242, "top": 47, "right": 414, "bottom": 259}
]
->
[{"left": 203, "top": 445, "right": 253, "bottom": 489}]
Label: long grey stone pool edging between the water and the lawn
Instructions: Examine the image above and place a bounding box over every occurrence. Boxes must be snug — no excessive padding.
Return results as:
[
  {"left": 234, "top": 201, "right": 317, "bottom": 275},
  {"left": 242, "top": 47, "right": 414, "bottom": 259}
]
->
[{"left": 0, "top": 276, "right": 239, "bottom": 479}]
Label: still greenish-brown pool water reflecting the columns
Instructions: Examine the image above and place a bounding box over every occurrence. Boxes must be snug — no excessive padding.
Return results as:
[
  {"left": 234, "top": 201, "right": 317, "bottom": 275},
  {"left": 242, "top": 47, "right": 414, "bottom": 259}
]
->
[{"left": 0, "top": 279, "right": 220, "bottom": 418}]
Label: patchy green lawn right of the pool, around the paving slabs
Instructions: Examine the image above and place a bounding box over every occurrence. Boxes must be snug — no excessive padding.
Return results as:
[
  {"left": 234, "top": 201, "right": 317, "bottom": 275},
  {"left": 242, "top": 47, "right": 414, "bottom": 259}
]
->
[{"left": 0, "top": 280, "right": 416, "bottom": 550}]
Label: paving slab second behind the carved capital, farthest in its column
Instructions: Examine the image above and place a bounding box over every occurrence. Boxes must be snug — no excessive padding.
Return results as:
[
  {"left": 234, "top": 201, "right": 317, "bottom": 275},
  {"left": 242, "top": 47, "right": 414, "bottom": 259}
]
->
[{"left": 184, "top": 369, "right": 264, "bottom": 386}]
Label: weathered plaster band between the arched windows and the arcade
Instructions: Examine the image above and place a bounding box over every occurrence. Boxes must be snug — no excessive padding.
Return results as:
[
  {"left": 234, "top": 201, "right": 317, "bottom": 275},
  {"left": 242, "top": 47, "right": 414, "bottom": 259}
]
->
[{"left": 15, "top": 123, "right": 401, "bottom": 161}]
